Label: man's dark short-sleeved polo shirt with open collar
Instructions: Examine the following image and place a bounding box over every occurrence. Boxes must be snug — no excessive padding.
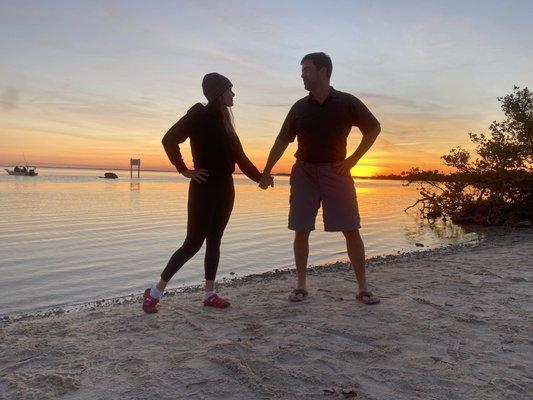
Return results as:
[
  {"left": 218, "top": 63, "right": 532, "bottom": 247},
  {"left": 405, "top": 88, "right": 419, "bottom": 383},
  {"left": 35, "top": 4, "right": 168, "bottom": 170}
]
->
[{"left": 278, "top": 88, "right": 379, "bottom": 163}]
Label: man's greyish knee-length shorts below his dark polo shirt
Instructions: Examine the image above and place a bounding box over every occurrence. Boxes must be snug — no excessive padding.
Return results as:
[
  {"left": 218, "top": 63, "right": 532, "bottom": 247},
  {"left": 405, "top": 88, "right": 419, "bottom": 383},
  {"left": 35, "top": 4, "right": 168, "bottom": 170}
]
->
[{"left": 289, "top": 160, "right": 361, "bottom": 232}]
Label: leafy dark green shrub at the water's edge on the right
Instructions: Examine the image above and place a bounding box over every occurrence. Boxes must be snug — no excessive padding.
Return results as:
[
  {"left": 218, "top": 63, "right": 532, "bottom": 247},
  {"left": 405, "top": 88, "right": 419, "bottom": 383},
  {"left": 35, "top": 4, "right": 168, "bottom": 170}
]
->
[{"left": 402, "top": 86, "right": 533, "bottom": 225}]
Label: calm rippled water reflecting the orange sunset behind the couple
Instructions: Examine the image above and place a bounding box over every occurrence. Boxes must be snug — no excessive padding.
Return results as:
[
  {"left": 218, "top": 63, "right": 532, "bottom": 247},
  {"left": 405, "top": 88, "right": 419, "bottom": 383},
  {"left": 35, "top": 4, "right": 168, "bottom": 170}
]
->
[{"left": 0, "top": 168, "right": 477, "bottom": 315}]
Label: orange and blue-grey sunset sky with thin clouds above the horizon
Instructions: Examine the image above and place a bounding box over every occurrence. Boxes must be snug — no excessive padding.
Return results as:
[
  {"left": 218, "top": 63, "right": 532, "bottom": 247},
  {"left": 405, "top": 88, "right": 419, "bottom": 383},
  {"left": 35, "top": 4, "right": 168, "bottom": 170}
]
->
[{"left": 0, "top": 0, "right": 533, "bottom": 175}]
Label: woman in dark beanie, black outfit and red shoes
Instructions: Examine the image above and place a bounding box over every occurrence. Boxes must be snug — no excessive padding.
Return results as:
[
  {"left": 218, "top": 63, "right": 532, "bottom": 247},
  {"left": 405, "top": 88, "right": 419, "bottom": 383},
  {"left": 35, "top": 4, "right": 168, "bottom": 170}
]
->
[{"left": 142, "top": 73, "right": 270, "bottom": 313}]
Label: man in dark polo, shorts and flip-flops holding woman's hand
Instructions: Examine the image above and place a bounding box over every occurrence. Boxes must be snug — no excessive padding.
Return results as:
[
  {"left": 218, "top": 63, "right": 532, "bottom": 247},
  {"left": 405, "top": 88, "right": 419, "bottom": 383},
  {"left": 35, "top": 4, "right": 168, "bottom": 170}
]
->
[{"left": 259, "top": 53, "right": 381, "bottom": 304}]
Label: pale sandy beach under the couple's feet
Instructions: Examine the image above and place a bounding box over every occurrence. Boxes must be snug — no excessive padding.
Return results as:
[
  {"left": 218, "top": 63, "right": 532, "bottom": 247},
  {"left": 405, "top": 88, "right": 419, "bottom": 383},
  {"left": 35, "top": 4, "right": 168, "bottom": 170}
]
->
[{"left": 0, "top": 230, "right": 533, "bottom": 400}]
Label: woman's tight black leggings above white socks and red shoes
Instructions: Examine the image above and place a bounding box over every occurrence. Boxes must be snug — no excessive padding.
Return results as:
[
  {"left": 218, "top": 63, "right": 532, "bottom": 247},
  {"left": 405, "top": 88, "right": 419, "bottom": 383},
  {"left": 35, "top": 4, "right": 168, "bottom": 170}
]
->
[{"left": 161, "top": 175, "right": 235, "bottom": 282}]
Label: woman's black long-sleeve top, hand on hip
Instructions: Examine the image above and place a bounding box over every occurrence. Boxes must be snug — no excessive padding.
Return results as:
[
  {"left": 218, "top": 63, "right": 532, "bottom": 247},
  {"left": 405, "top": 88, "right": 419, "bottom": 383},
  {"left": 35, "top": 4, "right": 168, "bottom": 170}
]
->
[{"left": 162, "top": 103, "right": 261, "bottom": 182}]
